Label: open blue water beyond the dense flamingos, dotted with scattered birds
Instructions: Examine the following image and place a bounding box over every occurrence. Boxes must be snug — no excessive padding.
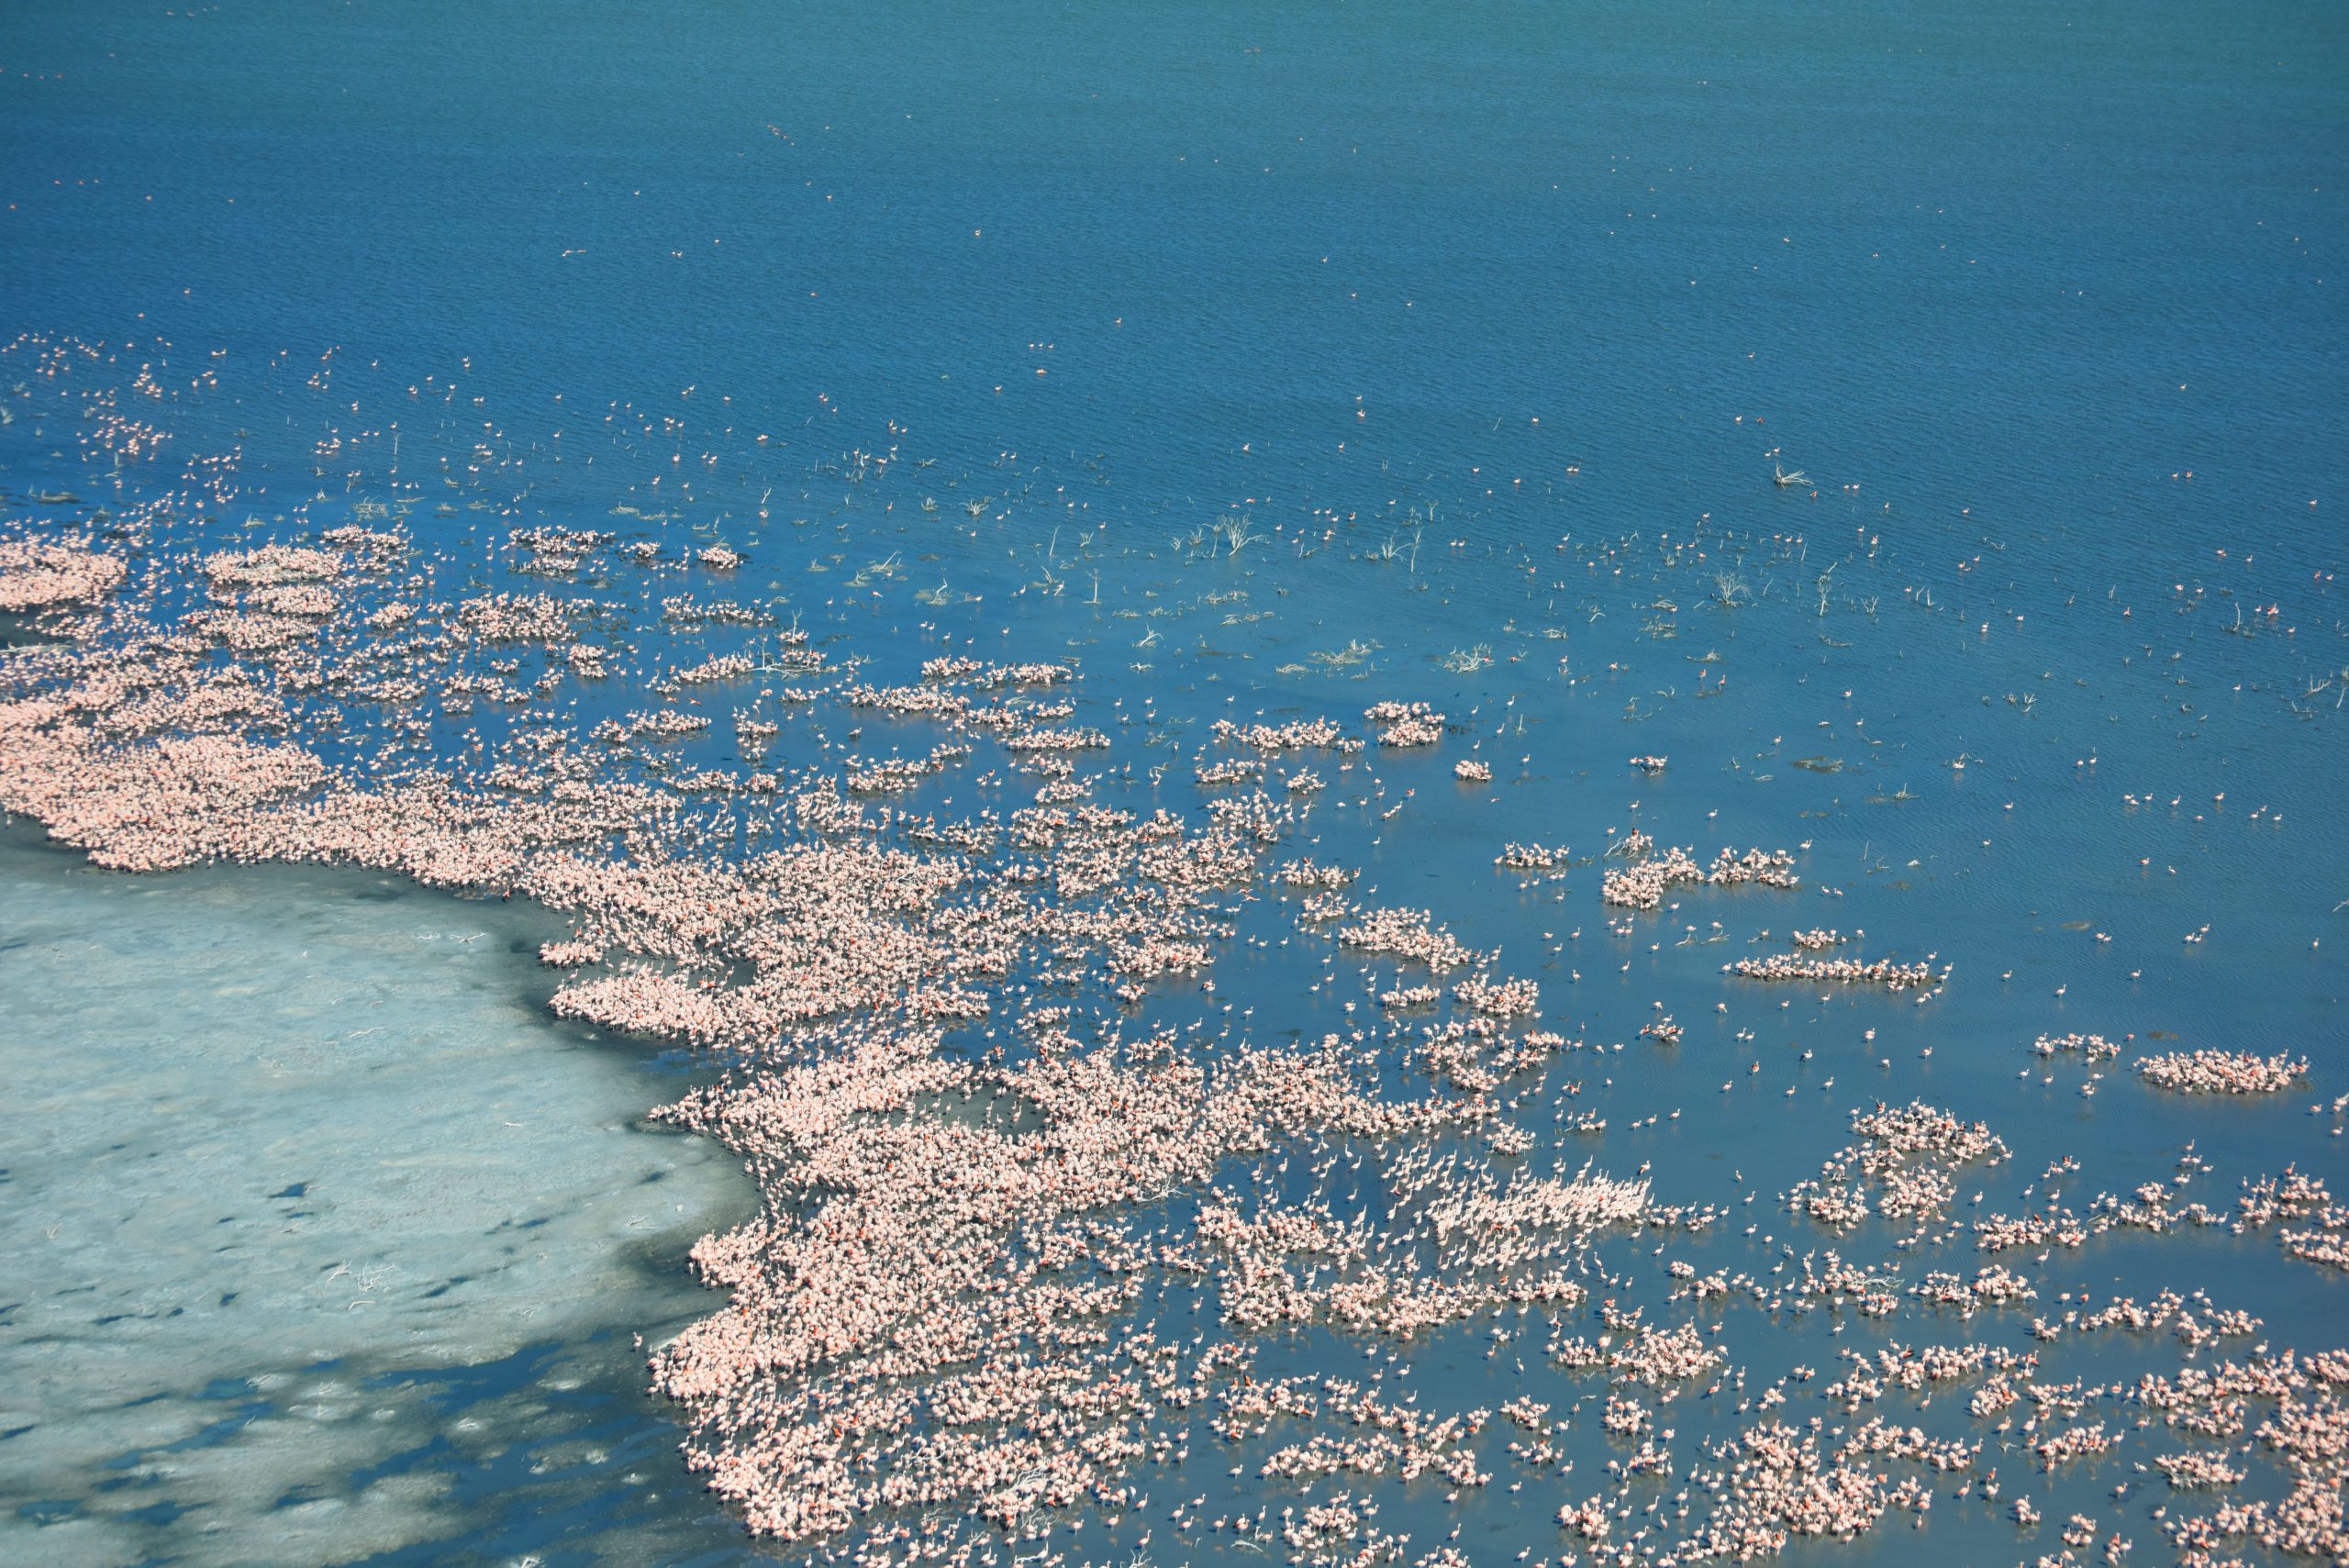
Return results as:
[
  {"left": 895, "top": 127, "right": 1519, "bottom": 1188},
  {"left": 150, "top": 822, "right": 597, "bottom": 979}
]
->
[{"left": 0, "top": 5, "right": 2349, "bottom": 1563}]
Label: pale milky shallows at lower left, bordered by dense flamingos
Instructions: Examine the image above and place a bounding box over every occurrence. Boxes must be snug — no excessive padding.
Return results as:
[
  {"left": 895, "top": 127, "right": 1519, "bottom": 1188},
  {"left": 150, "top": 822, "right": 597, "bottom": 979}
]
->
[{"left": 0, "top": 833, "right": 751, "bottom": 1563}]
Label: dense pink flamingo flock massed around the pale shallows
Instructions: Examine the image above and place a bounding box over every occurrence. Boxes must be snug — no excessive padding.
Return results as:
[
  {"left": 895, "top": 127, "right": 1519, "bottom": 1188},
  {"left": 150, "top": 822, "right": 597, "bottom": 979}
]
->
[{"left": 0, "top": 350, "right": 2349, "bottom": 1568}]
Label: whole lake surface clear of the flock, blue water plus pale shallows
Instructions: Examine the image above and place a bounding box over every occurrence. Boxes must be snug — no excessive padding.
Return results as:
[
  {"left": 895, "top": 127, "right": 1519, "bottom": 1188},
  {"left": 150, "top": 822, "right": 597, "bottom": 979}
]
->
[{"left": 0, "top": 0, "right": 2349, "bottom": 1563}]
